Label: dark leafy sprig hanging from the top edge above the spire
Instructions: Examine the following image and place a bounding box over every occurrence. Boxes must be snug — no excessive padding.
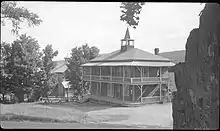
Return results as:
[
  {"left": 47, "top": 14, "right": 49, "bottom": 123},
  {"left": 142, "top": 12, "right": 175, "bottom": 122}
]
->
[{"left": 120, "top": 2, "right": 145, "bottom": 28}]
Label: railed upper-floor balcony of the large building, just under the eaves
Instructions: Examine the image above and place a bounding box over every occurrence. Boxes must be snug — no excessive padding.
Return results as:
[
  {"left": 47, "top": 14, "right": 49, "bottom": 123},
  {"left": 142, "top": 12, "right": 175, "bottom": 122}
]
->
[{"left": 83, "top": 66, "right": 167, "bottom": 84}]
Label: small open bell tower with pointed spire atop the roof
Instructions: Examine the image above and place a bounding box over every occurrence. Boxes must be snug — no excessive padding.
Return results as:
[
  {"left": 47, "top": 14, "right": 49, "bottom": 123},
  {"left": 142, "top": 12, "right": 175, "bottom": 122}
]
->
[{"left": 121, "top": 28, "right": 134, "bottom": 52}]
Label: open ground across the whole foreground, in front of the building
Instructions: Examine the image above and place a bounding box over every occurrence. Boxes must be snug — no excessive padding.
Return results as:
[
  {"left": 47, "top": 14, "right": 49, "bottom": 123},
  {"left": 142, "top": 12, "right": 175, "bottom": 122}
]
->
[{"left": 1, "top": 103, "right": 172, "bottom": 129}]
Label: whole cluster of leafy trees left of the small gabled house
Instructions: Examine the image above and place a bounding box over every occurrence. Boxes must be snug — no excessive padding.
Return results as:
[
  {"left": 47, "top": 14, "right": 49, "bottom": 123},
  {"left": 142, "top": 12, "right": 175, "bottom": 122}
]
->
[{"left": 1, "top": 39, "right": 58, "bottom": 101}]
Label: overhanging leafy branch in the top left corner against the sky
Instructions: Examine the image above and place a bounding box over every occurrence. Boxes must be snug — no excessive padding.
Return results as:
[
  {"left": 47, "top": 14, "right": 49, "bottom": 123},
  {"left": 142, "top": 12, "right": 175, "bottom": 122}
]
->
[{"left": 1, "top": 1, "right": 42, "bottom": 35}]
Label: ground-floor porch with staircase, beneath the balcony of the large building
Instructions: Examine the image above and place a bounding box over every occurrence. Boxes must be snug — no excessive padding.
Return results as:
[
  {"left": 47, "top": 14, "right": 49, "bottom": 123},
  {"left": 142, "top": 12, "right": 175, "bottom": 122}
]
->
[{"left": 87, "top": 82, "right": 166, "bottom": 105}]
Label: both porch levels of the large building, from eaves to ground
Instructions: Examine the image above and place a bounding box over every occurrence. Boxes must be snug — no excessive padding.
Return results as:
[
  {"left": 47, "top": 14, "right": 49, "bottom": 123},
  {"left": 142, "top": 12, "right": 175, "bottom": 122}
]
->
[{"left": 83, "top": 66, "right": 170, "bottom": 106}]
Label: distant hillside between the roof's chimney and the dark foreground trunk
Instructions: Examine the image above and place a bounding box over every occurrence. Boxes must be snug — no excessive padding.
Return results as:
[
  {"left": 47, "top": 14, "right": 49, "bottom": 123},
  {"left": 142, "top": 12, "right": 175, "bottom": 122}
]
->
[{"left": 159, "top": 50, "right": 185, "bottom": 63}]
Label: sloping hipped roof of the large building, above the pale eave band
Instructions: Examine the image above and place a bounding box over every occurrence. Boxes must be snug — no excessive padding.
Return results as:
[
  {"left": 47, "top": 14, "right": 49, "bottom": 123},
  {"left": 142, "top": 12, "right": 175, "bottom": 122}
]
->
[{"left": 90, "top": 48, "right": 171, "bottom": 62}]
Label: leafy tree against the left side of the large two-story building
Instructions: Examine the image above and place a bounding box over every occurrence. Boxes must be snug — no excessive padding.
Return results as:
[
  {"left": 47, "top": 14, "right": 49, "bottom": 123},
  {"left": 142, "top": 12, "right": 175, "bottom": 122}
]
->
[{"left": 66, "top": 44, "right": 99, "bottom": 95}]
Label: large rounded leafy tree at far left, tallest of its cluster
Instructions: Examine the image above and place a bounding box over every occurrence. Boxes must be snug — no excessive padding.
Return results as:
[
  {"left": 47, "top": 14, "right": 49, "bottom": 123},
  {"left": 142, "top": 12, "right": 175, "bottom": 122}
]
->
[{"left": 1, "top": 34, "right": 41, "bottom": 101}]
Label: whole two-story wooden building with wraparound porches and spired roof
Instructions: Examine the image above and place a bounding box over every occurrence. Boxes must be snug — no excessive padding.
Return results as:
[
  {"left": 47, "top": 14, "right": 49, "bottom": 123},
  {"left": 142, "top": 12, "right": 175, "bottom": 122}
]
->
[{"left": 82, "top": 29, "right": 174, "bottom": 104}]
